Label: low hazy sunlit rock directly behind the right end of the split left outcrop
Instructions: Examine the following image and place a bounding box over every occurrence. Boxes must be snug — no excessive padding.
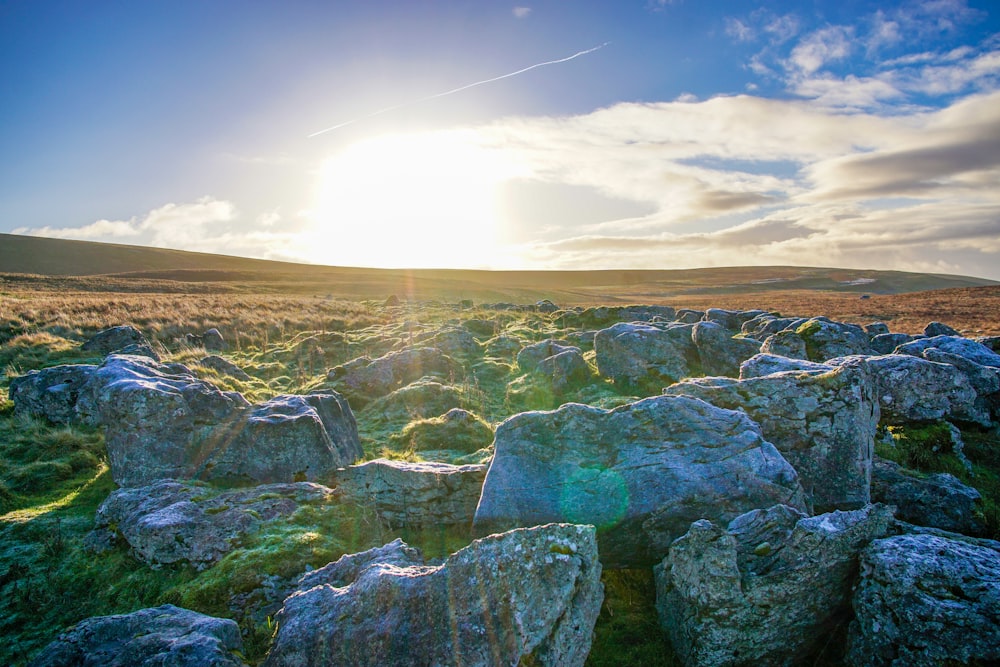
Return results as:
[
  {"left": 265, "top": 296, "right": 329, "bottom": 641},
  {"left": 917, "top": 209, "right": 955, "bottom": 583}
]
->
[{"left": 329, "top": 347, "right": 461, "bottom": 399}]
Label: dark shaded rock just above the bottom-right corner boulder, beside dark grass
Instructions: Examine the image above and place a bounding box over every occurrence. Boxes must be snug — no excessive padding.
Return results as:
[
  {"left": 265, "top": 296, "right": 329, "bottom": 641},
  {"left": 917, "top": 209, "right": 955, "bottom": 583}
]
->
[{"left": 872, "top": 459, "right": 986, "bottom": 536}]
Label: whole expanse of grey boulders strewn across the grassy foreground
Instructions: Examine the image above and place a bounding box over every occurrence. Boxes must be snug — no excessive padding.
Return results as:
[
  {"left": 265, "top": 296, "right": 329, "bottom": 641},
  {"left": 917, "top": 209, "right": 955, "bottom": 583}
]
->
[{"left": 17, "top": 310, "right": 1000, "bottom": 667}]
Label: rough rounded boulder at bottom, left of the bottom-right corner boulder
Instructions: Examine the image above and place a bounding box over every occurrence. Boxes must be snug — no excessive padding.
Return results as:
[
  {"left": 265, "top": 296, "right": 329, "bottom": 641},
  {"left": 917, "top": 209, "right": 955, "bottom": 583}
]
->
[{"left": 654, "top": 505, "right": 892, "bottom": 667}]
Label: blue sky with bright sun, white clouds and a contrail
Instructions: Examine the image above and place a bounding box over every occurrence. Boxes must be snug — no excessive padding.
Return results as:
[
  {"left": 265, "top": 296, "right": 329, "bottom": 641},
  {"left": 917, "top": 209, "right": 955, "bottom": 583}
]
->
[{"left": 0, "top": 0, "right": 1000, "bottom": 280}]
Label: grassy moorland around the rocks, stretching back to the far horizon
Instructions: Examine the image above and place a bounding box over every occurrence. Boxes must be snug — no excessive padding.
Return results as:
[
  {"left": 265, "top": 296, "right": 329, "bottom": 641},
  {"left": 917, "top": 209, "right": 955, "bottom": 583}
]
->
[{"left": 0, "top": 237, "right": 1000, "bottom": 665}]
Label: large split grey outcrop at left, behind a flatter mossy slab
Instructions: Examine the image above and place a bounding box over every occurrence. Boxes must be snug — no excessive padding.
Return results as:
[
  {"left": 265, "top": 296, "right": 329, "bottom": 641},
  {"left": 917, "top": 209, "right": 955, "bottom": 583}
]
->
[{"left": 77, "top": 355, "right": 362, "bottom": 486}]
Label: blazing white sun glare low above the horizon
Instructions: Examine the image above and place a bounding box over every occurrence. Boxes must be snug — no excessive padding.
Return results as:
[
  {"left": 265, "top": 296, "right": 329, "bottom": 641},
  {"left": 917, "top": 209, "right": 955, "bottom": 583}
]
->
[{"left": 309, "top": 130, "right": 517, "bottom": 268}]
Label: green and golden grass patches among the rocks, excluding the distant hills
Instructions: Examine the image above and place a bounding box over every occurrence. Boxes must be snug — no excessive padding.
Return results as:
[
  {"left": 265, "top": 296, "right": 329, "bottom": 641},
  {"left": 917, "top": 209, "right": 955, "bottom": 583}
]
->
[{"left": 0, "top": 268, "right": 1000, "bottom": 665}]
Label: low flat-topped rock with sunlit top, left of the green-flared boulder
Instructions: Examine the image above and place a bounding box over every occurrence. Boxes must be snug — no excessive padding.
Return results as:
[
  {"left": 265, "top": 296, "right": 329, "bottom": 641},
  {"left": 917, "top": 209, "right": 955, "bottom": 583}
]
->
[{"left": 334, "top": 459, "right": 486, "bottom": 527}]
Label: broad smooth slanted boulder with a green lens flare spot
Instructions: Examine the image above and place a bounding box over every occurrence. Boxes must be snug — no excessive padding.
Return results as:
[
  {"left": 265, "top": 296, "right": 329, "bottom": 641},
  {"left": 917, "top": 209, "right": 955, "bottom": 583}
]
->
[{"left": 474, "top": 396, "right": 805, "bottom": 567}]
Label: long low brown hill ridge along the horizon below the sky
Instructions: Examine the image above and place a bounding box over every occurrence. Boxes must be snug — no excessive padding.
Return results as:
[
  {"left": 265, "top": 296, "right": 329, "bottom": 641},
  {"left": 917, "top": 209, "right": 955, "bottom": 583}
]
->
[{"left": 0, "top": 234, "right": 1000, "bottom": 302}]
